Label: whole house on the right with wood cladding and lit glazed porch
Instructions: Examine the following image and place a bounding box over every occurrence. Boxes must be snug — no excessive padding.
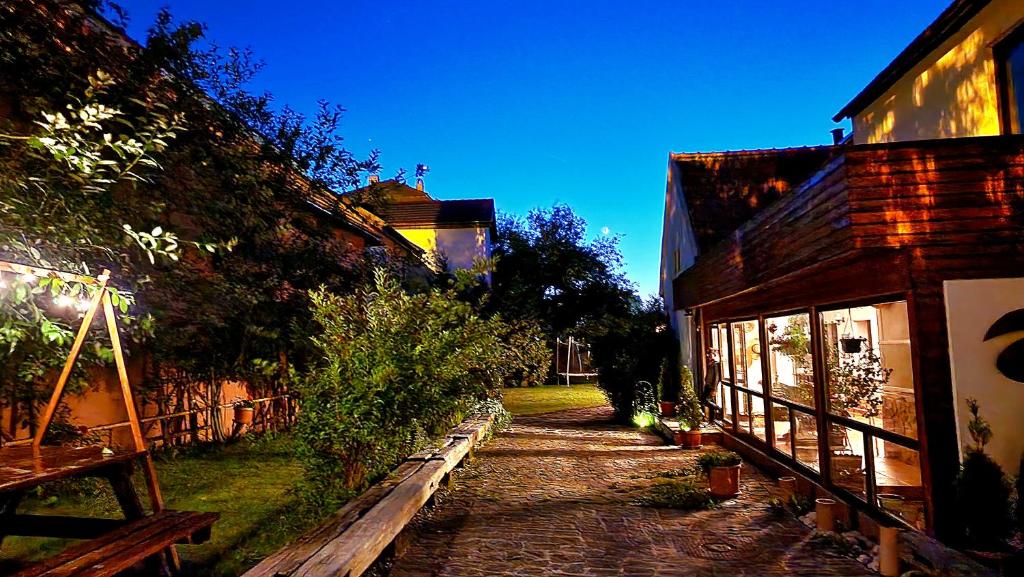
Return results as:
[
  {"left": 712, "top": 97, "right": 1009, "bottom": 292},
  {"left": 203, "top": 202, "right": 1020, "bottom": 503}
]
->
[{"left": 663, "top": 0, "right": 1024, "bottom": 537}]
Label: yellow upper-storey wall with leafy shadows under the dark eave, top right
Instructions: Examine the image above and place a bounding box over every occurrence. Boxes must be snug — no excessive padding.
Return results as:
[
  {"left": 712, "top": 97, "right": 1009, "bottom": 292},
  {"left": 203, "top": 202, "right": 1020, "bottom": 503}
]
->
[{"left": 853, "top": 0, "right": 1024, "bottom": 145}]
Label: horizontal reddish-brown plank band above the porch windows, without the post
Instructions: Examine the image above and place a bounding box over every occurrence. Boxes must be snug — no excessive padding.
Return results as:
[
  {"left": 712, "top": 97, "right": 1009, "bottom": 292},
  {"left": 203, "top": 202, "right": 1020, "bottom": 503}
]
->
[{"left": 674, "top": 135, "right": 1024, "bottom": 308}]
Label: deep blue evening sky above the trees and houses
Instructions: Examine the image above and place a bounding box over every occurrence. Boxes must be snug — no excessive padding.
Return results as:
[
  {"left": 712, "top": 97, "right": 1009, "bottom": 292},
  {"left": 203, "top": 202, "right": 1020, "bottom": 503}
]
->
[{"left": 122, "top": 0, "right": 949, "bottom": 294}]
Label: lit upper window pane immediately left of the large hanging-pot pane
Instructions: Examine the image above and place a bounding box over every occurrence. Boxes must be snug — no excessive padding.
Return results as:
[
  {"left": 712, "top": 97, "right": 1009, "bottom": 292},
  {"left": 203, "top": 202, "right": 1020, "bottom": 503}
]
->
[{"left": 765, "top": 313, "right": 814, "bottom": 407}]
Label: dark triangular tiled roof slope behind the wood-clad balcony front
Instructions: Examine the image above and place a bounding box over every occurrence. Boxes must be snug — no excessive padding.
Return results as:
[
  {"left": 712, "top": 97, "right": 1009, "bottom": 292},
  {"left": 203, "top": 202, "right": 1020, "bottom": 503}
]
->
[{"left": 670, "top": 146, "right": 837, "bottom": 252}]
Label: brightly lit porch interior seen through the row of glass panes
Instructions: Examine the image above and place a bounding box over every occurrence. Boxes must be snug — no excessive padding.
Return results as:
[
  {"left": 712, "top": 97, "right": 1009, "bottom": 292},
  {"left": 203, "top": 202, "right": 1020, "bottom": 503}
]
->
[{"left": 706, "top": 300, "right": 926, "bottom": 529}]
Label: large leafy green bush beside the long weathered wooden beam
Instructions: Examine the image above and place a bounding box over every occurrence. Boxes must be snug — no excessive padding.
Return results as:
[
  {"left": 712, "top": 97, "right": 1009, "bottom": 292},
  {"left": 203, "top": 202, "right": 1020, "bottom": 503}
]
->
[{"left": 297, "top": 270, "right": 544, "bottom": 494}]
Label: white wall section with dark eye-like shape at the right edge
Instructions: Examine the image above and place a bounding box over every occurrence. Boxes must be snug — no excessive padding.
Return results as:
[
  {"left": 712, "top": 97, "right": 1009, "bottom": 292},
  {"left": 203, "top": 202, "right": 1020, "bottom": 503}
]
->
[{"left": 944, "top": 278, "right": 1024, "bottom": 475}]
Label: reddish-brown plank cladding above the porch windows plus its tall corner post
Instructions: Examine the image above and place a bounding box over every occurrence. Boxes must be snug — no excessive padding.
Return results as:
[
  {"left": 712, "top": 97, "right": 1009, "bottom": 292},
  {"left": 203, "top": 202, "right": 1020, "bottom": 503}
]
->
[{"left": 673, "top": 135, "right": 1024, "bottom": 537}]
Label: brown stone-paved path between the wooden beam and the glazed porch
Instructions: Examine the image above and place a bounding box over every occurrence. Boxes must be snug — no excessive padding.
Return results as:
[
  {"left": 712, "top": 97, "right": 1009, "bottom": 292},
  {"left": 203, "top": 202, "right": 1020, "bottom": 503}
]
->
[{"left": 390, "top": 407, "right": 877, "bottom": 577}]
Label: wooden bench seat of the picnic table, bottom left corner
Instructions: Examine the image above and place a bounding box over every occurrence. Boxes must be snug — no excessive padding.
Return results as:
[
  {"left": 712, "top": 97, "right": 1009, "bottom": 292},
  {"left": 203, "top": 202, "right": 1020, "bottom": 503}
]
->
[{"left": 13, "top": 510, "right": 220, "bottom": 577}]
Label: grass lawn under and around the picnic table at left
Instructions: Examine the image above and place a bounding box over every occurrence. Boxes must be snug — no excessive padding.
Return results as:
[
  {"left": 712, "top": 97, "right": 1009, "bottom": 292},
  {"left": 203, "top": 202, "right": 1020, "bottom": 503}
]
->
[{"left": 0, "top": 436, "right": 330, "bottom": 577}]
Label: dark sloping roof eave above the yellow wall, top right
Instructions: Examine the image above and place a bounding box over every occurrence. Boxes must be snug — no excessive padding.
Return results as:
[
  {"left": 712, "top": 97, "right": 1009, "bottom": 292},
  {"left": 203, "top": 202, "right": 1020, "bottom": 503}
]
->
[{"left": 833, "top": 0, "right": 991, "bottom": 122}]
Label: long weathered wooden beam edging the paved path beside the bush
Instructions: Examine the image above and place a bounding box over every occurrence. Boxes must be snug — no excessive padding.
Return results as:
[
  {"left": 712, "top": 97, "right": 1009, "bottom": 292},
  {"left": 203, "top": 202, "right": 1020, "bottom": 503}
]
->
[{"left": 243, "top": 415, "right": 494, "bottom": 577}]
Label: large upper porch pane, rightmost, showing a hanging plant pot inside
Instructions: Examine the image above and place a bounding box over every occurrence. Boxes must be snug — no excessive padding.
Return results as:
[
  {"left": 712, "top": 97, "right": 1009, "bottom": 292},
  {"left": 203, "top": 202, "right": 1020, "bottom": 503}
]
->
[{"left": 821, "top": 300, "right": 918, "bottom": 439}]
